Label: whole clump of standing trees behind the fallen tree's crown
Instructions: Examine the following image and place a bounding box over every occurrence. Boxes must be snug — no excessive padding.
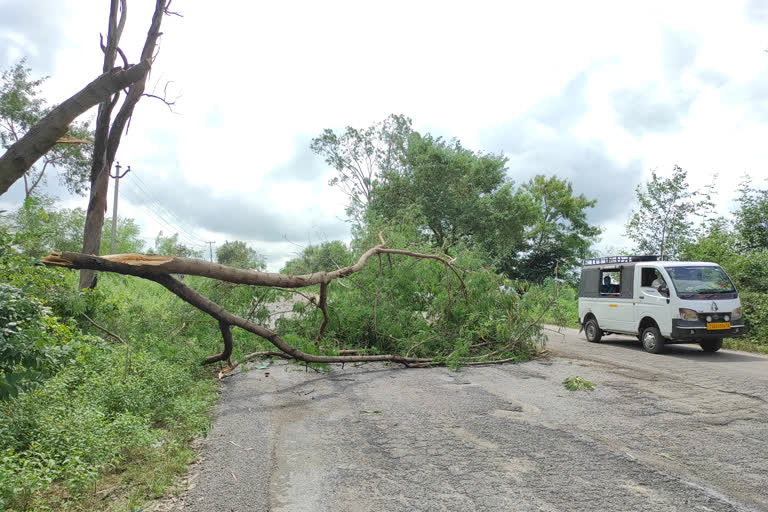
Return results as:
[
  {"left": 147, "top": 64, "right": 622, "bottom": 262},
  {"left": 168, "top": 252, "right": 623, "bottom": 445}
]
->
[{"left": 312, "top": 116, "right": 600, "bottom": 281}]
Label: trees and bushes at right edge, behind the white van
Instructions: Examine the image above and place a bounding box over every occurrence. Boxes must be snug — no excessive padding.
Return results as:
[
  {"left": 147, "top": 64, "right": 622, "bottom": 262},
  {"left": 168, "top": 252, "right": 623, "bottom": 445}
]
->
[{"left": 626, "top": 166, "right": 768, "bottom": 352}]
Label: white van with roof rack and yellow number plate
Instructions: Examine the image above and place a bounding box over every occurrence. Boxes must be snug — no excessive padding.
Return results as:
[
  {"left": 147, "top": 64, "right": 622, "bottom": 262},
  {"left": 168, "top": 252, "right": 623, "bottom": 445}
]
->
[{"left": 579, "top": 256, "right": 744, "bottom": 354}]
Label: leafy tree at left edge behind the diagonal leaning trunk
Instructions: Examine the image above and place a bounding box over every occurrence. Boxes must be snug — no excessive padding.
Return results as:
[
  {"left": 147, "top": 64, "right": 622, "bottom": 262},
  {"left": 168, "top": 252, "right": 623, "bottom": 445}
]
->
[{"left": 0, "top": 60, "right": 93, "bottom": 199}]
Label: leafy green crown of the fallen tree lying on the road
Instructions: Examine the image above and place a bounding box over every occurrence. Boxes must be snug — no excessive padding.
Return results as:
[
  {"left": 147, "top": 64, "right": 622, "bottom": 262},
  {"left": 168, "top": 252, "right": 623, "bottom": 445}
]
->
[{"left": 278, "top": 225, "right": 552, "bottom": 367}]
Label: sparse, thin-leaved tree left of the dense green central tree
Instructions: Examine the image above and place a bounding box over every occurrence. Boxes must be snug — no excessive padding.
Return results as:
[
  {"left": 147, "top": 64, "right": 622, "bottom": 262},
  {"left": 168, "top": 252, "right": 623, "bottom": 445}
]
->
[{"left": 310, "top": 114, "right": 412, "bottom": 222}]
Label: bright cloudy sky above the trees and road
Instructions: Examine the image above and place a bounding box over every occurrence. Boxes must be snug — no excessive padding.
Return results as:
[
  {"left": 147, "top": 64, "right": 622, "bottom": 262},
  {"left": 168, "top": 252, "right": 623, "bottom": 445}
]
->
[{"left": 0, "top": 0, "right": 768, "bottom": 269}]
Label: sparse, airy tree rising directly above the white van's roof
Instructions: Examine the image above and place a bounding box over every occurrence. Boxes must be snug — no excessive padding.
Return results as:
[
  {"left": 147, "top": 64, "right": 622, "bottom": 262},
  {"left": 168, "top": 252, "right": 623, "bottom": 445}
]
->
[{"left": 626, "top": 165, "right": 714, "bottom": 259}]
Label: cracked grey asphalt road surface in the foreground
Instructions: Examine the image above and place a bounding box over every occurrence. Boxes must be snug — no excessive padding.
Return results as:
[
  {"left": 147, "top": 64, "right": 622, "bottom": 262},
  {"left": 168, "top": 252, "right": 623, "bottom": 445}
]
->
[{"left": 168, "top": 329, "right": 768, "bottom": 512}]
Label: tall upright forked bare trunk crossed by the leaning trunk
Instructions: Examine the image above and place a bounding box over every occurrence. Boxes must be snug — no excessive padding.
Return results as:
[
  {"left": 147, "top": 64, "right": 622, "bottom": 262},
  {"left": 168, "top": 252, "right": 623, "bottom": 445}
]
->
[{"left": 80, "top": 0, "right": 167, "bottom": 289}]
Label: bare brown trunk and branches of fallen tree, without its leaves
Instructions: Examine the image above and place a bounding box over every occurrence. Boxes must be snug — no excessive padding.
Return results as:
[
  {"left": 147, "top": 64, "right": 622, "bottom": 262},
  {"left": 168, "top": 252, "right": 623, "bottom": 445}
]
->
[{"left": 43, "top": 234, "right": 556, "bottom": 367}]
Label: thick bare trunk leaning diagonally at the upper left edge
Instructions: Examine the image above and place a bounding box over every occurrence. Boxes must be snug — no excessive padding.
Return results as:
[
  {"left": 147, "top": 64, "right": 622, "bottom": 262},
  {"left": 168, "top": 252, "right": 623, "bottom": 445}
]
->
[{"left": 0, "top": 60, "right": 151, "bottom": 195}]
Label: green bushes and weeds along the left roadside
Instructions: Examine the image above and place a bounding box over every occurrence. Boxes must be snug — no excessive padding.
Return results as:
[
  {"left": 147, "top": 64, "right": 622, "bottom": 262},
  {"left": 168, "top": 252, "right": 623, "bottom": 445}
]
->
[{"left": 0, "top": 222, "right": 216, "bottom": 510}]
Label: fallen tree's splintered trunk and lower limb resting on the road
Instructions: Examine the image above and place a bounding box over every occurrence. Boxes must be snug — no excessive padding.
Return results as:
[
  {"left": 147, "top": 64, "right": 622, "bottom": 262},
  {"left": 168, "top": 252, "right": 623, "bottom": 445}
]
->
[{"left": 43, "top": 252, "right": 433, "bottom": 365}]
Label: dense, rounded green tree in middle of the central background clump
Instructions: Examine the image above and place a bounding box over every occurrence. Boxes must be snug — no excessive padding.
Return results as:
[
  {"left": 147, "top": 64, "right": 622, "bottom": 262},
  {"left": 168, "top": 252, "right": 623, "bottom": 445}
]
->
[{"left": 372, "top": 133, "right": 530, "bottom": 249}]
